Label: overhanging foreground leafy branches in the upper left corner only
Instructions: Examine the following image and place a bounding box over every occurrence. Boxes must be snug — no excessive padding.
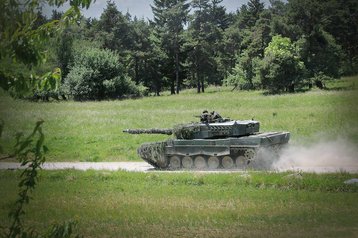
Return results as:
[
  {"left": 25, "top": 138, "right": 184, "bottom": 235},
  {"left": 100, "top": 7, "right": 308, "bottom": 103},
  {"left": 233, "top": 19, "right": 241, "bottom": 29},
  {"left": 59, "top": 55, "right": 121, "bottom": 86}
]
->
[{"left": 0, "top": 0, "right": 92, "bottom": 98}]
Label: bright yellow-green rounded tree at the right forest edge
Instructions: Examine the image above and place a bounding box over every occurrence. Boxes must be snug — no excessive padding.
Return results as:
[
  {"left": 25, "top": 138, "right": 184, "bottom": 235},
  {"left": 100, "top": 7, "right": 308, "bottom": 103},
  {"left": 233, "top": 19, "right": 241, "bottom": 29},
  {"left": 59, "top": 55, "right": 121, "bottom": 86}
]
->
[{"left": 259, "top": 35, "right": 305, "bottom": 92}]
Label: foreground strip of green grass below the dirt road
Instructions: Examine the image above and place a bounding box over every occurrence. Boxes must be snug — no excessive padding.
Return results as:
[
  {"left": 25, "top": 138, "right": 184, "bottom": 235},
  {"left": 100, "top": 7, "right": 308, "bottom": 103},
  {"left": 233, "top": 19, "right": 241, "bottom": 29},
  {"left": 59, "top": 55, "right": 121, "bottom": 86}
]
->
[{"left": 0, "top": 170, "right": 358, "bottom": 237}]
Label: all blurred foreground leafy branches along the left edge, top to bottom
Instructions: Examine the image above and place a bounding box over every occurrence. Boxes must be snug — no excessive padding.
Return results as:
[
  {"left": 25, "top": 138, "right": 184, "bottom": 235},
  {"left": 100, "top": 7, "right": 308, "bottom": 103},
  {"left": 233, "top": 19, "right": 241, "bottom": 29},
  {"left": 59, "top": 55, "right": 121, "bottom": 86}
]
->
[{"left": 0, "top": 0, "right": 92, "bottom": 237}]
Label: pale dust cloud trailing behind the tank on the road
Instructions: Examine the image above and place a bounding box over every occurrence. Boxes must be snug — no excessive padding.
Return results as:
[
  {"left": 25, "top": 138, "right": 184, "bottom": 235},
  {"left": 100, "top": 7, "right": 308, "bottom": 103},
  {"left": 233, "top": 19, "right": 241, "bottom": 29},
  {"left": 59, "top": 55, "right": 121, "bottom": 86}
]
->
[{"left": 271, "top": 138, "right": 358, "bottom": 173}]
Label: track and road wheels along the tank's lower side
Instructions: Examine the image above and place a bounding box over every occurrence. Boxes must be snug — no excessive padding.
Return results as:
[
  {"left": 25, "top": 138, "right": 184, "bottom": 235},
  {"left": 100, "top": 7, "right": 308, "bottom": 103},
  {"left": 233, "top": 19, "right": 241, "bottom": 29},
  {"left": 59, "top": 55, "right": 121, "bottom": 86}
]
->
[{"left": 137, "top": 142, "right": 283, "bottom": 170}]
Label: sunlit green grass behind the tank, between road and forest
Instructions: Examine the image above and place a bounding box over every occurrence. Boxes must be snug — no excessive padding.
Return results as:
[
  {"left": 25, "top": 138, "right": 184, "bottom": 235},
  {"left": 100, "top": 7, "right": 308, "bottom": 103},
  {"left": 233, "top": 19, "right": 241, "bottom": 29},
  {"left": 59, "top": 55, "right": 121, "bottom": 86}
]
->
[{"left": 0, "top": 76, "right": 358, "bottom": 161}]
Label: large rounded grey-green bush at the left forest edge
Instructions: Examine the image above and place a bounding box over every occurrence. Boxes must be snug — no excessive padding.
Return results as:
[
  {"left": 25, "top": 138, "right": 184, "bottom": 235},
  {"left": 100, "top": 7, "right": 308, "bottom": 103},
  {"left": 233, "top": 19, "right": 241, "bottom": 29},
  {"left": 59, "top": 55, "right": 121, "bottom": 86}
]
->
[{"left": 63, "top": 48, "right": 139, "bottom": 100}]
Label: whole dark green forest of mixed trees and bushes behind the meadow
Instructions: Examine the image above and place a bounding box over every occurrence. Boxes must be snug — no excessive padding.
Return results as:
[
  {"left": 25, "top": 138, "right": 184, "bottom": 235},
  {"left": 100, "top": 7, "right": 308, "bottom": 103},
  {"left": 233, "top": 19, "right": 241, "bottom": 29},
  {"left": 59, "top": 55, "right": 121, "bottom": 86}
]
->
[{"left": 0, "top": 0, "right": 358, "bottom": 101}]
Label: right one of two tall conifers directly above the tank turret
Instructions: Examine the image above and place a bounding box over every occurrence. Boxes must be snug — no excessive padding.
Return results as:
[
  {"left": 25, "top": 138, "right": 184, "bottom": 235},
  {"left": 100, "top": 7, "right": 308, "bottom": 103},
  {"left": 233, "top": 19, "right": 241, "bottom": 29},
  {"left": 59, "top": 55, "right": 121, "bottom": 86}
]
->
[{"left": 185, "top": 0, "right": 229, "bottom": 93}]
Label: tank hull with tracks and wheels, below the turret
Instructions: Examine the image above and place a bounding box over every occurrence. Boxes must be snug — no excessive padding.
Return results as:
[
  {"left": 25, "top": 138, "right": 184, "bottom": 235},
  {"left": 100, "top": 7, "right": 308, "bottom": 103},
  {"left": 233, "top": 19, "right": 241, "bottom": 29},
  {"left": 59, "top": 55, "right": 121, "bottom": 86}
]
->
[{"left": 137, "top": 132, "right": 290, "bottom": 170}]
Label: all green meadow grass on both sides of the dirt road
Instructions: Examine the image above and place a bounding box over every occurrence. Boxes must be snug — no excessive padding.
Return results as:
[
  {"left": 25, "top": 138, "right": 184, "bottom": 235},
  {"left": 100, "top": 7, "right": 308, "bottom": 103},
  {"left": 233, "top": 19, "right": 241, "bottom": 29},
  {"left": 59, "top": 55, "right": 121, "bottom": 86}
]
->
[{"left": 0, "top": 77, "right": 358, "bottom": 237}]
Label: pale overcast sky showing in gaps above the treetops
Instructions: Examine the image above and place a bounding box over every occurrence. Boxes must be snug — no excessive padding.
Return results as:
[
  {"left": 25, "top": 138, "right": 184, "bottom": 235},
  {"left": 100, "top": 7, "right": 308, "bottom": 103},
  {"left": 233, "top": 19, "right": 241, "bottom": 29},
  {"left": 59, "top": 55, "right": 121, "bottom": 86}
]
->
[{"left": 45, "top": 0, "right": 269, "bottom": 19}]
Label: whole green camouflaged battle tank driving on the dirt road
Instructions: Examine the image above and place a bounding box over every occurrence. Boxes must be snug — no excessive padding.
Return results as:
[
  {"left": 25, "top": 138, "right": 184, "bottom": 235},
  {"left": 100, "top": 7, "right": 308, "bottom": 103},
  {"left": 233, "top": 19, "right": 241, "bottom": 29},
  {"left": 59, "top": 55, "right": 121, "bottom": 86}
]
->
[{"left": 123, "top": 111, "right": 290, "bottom": 170}]
